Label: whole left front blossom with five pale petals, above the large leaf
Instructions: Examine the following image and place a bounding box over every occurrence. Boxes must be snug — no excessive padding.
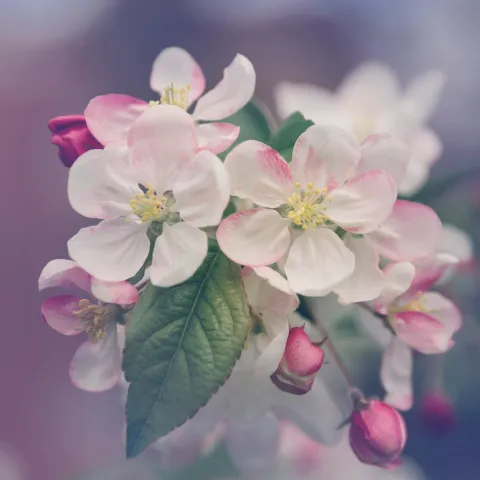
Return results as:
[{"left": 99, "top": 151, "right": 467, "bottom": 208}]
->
[{"left": 68, "top": 106, "right": 230, "bottom": 287}]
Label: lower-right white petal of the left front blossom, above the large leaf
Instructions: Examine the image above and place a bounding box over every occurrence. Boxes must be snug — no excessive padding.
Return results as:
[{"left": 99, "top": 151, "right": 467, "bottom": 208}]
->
[{"left": 150, "top": 222, "right": 208, "bottom": 287}]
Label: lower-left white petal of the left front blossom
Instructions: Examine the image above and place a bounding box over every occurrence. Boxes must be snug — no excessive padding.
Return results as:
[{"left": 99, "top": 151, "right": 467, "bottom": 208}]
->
[{"left": 67, "top": 218, "right": 150, "bottom": 282}]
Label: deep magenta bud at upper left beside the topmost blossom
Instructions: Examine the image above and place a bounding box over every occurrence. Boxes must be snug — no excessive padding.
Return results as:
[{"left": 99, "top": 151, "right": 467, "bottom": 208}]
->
[{"left": 48, "top": 115, "right": 103, "bottom": 167}]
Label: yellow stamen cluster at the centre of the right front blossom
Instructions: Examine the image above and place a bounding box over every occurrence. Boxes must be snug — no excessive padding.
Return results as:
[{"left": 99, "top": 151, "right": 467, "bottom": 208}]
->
[{"left": 287, "top": 182, "right": 330, "bottom": 230}]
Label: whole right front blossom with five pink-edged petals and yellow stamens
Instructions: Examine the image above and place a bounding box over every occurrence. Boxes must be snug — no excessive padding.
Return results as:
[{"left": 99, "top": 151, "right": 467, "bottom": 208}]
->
[{"left": 217, "top": 126, "right": 397, "bottom": 296}]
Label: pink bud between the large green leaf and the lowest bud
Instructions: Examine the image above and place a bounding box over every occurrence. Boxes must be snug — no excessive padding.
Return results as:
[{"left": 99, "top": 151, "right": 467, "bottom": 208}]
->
[{"left": 270, "top": 327, "right": 325, "bottom": 395}]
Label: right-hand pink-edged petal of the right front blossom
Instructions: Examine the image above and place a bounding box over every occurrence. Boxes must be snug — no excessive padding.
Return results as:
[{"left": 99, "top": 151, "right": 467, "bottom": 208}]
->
[{"left": 323, "top": 170, "right": 397, "bottom": 233}]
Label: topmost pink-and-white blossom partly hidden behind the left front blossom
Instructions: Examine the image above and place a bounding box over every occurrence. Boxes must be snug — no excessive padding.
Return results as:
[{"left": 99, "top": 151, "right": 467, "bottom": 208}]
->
[{"left": 85, "top": 47, "right": 256, "bottom": 153}]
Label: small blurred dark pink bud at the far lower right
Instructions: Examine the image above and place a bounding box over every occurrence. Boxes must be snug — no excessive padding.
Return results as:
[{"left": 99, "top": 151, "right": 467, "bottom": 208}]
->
[{"left": 420, "top": 392, "right": 456, "bottom": 435}]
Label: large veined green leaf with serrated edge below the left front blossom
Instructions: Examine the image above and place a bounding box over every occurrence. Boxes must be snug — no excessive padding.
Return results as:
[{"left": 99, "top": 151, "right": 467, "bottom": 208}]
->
[{"left": 123, "top": 240, "right": 250, "bottom": 457}]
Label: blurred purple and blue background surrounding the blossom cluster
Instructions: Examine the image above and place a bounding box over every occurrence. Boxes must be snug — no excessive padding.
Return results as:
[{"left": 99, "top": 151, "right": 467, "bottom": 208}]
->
[{"left": 0, "top": 0, "right": 480, "bottom": 480}]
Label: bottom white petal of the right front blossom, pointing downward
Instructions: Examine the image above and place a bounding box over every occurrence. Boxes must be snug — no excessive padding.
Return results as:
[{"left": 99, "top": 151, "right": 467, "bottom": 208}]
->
[{"left": 285, "top": 228, "right": 355, "bottom": 296}]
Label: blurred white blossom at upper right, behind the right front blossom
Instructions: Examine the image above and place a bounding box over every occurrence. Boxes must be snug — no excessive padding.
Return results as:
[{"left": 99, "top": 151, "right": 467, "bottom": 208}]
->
[{"left": 275, "top": 62, "right": 445, "bottom": 195}]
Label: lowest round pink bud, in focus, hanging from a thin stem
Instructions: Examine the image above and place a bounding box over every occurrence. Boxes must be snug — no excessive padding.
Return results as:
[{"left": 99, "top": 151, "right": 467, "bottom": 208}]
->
[{"left": 350, "top": 399, "right": 407, "bottom": 468}]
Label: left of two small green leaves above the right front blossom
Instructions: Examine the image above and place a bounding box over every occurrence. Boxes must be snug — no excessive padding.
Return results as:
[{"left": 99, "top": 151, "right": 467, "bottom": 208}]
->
[{"left": 218, "top": 101, "right": 271, "bottom": 160}]
